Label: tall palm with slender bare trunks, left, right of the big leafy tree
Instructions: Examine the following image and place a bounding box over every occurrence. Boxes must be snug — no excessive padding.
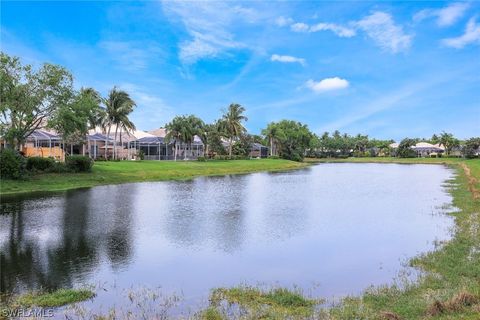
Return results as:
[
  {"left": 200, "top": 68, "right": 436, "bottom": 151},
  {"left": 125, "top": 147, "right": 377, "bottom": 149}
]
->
[{"left": 103, "top": 87, "right": 136, "bottom": 159}]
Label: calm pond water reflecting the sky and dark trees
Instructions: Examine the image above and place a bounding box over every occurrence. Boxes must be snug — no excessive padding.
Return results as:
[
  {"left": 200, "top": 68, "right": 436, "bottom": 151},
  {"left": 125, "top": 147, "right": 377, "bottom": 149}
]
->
[{"left": 0, "top": 164, "right": 452, "bottom": 304}]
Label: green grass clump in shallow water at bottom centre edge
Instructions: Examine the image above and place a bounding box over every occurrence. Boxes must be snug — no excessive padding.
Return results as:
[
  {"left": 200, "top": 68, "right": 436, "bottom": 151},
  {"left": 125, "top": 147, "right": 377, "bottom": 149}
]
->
[{"left": 204, "top": 286, "right": 319, "bottom": 319}]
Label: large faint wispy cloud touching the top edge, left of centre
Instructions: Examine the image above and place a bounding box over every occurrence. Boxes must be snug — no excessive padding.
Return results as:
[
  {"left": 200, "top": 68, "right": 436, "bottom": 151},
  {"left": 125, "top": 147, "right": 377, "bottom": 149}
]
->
[{"left": 163, "top": 1, "right": 259, "bottom": 64}]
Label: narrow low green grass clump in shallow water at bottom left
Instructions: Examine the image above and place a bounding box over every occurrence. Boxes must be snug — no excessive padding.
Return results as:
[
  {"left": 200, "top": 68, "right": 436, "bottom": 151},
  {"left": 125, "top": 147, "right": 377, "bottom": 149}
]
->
[{"left": 15, "top": 289, "right": 95, "bottom": 308}]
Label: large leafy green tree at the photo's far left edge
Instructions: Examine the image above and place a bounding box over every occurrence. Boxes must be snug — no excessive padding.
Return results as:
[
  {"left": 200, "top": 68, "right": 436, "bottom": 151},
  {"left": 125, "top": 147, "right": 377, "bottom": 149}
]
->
[{"left": 0, "top": 52, "right": 73, "bottom": 149}]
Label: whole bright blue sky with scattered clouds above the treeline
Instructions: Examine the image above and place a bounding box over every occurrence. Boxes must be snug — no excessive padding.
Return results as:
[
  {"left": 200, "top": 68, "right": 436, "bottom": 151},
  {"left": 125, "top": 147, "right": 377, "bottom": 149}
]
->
[{"left": 1, "top": 1, "right": 480, "bottom": 139}]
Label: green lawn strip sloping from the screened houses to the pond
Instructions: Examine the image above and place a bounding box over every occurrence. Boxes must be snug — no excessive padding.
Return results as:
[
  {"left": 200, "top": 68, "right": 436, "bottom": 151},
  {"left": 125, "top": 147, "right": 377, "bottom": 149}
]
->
[{"left": 0, "top": 159, "right": 308, "bottom": 195}]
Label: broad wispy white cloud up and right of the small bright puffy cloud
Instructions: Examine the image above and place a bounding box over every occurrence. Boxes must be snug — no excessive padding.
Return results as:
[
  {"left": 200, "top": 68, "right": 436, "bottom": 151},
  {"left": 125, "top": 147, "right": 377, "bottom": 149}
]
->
[{"left": 355, "top": 11, "right": 413, "bottom": 53}]
